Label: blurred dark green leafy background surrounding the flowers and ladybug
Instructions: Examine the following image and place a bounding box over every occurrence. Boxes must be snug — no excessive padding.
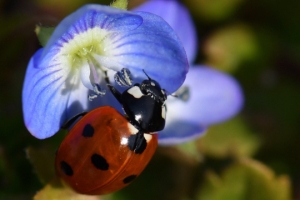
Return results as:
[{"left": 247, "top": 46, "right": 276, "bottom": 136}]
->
[{"left": 0, "top": 0, "right": 300, "bottom": 200}]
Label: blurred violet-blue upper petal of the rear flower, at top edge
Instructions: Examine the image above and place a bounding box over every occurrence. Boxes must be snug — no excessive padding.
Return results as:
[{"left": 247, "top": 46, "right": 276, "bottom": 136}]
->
[{"left": 133, "top": 0, "right": 198, "bottom": 63}]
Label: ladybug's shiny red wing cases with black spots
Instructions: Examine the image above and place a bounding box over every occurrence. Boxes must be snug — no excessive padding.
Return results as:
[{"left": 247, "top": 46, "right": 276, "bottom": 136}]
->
[{"left": 55, "top": 106, "right": 158, "bottom": 195}]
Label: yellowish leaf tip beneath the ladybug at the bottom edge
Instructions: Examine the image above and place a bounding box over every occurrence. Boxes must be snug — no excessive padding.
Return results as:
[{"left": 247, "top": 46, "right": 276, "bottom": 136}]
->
[{"left": 33, "top": 179, "right": 100, "bottom": 200}]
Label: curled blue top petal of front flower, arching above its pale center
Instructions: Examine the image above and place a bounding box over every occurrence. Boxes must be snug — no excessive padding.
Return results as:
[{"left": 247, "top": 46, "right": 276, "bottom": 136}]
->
[{"left": 45, "top": 4, "right": 143, "bottom": 57}]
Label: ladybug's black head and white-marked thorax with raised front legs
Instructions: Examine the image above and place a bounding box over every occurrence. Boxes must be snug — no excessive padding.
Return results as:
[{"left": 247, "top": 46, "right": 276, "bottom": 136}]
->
[{"left": 106, "top": 68, "right": 167, "bottom": 133}]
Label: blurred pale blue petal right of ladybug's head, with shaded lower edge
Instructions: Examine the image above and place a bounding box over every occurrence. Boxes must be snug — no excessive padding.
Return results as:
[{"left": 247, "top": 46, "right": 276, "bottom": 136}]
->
[{"left": 159, "top": 66, "right": 244, "bottom": 144}]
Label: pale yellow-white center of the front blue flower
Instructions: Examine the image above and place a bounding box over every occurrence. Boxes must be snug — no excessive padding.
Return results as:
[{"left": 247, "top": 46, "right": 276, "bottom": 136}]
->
[{"left": 58, "top": 27, "right": 111, "bottom": 100}]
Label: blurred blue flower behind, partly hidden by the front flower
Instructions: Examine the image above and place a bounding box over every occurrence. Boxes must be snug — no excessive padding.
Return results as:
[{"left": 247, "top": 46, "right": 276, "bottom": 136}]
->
[{"left": 134, "top": 0, "right": 244, "bottom": 145}]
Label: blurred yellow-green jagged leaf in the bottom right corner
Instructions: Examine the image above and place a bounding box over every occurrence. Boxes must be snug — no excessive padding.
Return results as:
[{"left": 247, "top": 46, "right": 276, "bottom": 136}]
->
[{"left": 197, "top": 159, "right": 291, "bottom": 200}]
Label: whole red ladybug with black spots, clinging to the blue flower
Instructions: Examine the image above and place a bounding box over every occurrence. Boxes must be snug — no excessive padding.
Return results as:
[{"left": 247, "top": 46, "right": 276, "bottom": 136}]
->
[{"left": 55, "top": 68, "right": 167, "bottom": 195}]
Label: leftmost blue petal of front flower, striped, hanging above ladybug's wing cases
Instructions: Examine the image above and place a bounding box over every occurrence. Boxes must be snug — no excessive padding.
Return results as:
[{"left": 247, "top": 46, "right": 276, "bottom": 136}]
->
[{"left": 22, "top": 49, "right": 117, "bottom": 139}]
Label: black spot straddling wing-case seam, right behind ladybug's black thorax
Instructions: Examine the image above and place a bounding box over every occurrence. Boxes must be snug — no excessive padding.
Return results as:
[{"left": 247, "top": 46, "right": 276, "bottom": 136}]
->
[{"left": 128, "top": 132, "right": 147, "bottom": 154}]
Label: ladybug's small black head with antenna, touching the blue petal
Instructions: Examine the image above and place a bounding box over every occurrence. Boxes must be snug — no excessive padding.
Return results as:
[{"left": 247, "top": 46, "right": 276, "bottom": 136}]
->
[{"left": 140, "top": 71, "right": 167, "bottom": 104}]
